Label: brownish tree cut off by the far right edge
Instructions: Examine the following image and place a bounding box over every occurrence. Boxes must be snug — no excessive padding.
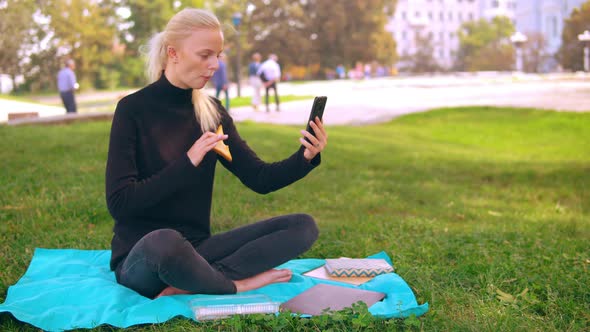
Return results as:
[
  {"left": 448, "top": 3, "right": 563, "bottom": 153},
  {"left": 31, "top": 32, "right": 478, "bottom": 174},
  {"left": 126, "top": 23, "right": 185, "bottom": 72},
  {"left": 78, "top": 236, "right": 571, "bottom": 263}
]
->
[{"left": 557, "top": 1, "right": 590, "bottom": 71}]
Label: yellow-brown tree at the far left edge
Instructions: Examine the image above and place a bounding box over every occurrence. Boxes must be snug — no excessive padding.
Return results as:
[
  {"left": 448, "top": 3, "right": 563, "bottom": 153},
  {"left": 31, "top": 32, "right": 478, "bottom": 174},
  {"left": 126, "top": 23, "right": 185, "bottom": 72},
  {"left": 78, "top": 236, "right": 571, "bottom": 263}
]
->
[{"left": 0, "top": 0, "right": 34, "bottom": 91}]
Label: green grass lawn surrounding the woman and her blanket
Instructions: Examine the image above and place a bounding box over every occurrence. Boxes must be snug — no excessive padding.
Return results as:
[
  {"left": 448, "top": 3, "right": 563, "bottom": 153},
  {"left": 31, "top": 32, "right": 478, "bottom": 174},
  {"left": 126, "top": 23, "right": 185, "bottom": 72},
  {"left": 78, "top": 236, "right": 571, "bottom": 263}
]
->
[{"left": 0, "top": 108, "right": 590, "bottom": 331}]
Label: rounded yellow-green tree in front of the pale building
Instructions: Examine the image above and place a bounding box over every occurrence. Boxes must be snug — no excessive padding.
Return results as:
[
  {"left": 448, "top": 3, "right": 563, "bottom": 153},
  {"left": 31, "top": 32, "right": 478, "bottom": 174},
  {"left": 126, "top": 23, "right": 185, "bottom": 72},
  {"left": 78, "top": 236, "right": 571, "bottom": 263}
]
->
[{"left": 455, "top": 16, "right": 515, "bottom": 71}]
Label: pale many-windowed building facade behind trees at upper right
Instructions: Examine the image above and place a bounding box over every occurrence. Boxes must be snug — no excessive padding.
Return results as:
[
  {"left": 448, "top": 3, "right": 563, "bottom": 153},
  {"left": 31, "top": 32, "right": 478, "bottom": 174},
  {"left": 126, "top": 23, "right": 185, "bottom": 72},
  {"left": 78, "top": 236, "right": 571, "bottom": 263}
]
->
[{"left": 387, "top": 0, "right": 587, "bottom": 70}]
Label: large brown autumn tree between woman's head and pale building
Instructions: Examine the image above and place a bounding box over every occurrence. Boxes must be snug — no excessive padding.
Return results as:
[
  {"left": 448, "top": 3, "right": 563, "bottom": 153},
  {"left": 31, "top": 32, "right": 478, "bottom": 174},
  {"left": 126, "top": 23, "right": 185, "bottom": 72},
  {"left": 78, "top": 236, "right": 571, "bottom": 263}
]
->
[{"left": 247, "top": 0, "right": 396, "bottom": 76}]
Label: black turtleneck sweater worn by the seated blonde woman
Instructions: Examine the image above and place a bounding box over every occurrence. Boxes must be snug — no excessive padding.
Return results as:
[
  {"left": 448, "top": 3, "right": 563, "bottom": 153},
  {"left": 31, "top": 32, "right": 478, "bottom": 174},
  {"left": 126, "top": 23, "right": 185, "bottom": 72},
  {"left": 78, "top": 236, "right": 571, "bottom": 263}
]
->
[{"left": 106, "top": 75, "right": 320, "bottom": 270}]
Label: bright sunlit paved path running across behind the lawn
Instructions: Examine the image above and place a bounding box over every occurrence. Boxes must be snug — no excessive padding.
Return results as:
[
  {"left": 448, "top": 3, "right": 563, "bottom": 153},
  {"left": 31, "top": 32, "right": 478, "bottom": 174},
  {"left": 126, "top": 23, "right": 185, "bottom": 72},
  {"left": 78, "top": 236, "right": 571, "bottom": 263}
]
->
[{"left": 0, "top": 73, "right": 590, "bottom": 125}]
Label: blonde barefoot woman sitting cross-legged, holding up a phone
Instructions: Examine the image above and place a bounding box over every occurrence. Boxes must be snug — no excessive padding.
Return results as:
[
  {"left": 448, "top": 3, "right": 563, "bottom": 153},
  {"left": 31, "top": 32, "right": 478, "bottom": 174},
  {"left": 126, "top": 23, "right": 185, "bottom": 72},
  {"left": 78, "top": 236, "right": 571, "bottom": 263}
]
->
[{"left": 106, "top": 9, "right": 327, "bottom": 298}]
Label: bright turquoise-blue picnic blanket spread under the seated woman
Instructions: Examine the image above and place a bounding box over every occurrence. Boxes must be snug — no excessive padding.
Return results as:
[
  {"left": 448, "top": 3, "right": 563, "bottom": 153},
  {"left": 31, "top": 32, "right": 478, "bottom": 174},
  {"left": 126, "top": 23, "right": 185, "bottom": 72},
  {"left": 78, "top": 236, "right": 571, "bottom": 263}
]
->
[{"left": 0, "top": 248, "right": 428, "bottom": 331}]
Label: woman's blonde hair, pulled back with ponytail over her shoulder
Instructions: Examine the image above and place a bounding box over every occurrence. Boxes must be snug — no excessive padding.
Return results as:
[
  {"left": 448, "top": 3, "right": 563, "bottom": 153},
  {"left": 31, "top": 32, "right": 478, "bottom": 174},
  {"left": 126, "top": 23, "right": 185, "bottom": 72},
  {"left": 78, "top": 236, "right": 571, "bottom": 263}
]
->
[{"left": 146, "top": 8, "right": 221, "bottom": 132}]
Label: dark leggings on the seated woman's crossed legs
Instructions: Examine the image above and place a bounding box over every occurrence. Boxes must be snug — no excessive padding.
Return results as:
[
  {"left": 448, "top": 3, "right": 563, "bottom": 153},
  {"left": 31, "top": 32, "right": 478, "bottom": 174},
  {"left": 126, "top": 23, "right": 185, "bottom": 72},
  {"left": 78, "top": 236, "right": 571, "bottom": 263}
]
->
[{"left": 115, "top": 214, "right": 318, "bottom": 298}]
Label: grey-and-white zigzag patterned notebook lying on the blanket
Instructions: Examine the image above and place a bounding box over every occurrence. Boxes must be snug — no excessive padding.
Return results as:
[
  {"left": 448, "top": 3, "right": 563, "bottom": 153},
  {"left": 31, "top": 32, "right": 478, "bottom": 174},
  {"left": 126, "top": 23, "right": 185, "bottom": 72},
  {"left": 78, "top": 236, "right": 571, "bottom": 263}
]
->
[{"left": 325, "top": 258, "right": 393, "bottom": 277}]
